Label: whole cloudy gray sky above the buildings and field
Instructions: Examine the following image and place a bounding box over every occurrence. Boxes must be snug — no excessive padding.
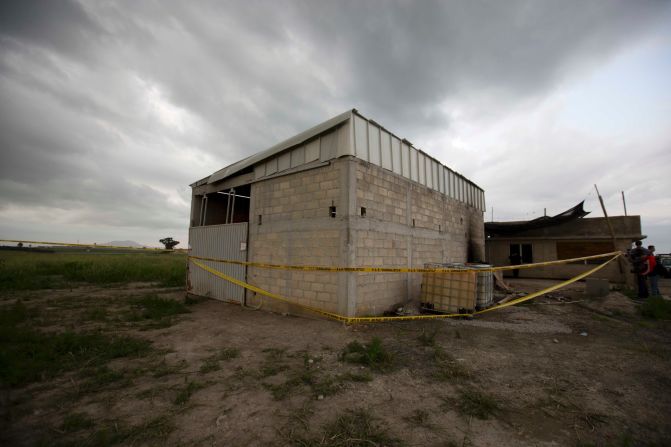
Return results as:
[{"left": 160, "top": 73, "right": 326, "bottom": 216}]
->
[{"left": 0, "top": 0, "right": 671, "bottom": 252}]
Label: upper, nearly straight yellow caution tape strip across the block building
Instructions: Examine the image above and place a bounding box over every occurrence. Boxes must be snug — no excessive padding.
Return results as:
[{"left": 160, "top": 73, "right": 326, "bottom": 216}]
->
[{"left": 189, "top": 251, "right": 622, "bottom": 273}]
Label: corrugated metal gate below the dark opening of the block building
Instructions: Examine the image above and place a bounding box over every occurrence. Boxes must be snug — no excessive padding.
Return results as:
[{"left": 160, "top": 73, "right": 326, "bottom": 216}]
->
[{"left": 188, "top": 222, "right": 247, "bottom": 302}]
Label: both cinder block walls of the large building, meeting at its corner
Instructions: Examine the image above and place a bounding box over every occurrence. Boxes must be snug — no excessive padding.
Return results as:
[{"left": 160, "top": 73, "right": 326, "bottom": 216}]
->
[{"left": 247, "top": 157, "right": 484, "bottom": 316}]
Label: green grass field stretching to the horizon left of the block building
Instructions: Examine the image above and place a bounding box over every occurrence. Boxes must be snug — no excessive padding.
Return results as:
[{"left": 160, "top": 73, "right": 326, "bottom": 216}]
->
[{"left": 0, "top": 252, "right": 186, "bottom": 290}]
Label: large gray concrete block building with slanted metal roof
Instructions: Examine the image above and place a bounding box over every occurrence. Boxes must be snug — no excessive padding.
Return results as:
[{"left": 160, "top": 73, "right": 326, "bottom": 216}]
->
[{"left": 188, "top": 110, "right": 485, "bottom": 316}]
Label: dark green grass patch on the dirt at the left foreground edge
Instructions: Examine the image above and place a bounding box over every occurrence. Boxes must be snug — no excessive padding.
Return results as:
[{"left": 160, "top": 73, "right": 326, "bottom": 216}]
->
[{"left": 0, "top": 301, "right": 151, "bottom": 386}]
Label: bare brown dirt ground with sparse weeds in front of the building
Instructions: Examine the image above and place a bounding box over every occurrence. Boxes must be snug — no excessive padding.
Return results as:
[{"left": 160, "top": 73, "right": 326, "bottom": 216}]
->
[{"left": 0, "top": 280, "right": 671, "bottom": 446}]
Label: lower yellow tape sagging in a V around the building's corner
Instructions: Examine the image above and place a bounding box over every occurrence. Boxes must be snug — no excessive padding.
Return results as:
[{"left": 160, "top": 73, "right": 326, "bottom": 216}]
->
[{"left": 189, "top": 252, "right": 621, "bottom": 324}]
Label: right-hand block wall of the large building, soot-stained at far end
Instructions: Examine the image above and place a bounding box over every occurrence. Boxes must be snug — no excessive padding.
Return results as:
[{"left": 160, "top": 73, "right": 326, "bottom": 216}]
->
[{"left": 351, "top": 160, "right": 484, "bottom": 314}]
